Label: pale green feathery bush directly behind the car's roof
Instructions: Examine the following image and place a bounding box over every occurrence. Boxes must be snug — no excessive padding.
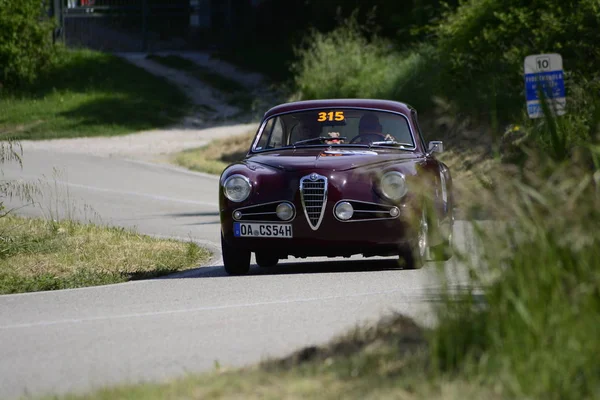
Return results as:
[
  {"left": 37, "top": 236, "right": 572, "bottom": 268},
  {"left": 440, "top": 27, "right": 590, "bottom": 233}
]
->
[{"left": 292, "top": 16, "right": 441, "bottom": 110}]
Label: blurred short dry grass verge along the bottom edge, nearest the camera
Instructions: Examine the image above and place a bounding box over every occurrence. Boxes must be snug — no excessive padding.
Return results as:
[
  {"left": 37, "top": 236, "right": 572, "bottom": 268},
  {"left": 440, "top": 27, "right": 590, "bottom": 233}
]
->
[{"left": 65, "top": 316, "right": 502, "bottom": 400}]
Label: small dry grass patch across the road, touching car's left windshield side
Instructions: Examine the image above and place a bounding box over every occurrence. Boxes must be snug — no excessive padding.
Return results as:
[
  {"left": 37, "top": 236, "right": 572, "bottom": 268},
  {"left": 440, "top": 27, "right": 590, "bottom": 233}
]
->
[{"left": 172, "top": 131, "right": 255, "bottom": 175}]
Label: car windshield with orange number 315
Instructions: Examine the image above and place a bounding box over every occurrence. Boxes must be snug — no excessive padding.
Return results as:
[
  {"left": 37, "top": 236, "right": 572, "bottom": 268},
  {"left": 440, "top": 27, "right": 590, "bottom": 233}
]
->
[{"left": 253, "top": 108, "right": 415, "bottom": 151}]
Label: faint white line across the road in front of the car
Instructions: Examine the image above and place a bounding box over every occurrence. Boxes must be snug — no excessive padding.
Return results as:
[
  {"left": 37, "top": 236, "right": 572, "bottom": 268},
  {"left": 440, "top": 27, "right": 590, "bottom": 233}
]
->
[{"left": 0, "top": 289, "right": 432, "bottom": 330}]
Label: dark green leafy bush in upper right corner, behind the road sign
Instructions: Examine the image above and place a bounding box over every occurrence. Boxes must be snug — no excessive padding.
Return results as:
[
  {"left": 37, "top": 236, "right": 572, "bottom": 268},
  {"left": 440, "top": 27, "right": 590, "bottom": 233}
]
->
[{"left": 433, "top": 0, "right": 600, "bottom": 121}]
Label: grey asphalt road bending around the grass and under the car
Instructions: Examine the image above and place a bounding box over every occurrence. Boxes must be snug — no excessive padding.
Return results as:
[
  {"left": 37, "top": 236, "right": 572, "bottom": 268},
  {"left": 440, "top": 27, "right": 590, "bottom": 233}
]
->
[{"left": 0, "top": 151, "right": 469, "bottom": 398}]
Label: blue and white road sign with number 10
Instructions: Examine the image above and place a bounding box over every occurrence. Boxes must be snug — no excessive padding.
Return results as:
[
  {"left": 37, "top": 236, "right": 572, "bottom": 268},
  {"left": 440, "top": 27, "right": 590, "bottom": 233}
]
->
[{"left": 524, "top": 54, "right": 567, "bottom": 118}]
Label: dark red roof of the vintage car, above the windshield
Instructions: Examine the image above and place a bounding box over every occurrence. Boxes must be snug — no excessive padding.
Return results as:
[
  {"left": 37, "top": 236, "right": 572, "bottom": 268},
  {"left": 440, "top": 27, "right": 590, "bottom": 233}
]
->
[{"left": 264, "top": 99, "right": 413, "bottom": 119}]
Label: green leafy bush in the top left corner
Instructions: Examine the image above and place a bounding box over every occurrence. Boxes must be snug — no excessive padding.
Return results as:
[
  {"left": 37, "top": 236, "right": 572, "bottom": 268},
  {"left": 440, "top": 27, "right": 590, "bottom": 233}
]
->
[{"left": 0, "top": 0, "right": 54, "bottom": 88}]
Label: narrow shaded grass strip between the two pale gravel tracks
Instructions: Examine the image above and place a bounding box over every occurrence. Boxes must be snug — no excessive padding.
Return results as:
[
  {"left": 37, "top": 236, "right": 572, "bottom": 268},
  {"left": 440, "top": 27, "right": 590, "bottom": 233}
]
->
[{"left": 146, "top": 54, "right": 254, "bottom": 112}]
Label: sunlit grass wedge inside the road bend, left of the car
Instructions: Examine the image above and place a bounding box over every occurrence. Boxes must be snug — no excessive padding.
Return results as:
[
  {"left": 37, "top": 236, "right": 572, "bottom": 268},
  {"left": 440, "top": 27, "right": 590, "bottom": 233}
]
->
[{"left": 0, "top": 215, "right": 210, "bottom": 294}]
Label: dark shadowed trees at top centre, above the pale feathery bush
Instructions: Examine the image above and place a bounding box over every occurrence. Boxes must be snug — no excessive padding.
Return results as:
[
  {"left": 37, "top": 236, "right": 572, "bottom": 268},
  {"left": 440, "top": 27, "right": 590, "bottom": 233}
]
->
[{"left": 216, "top": 0, "right": 458, "bottom": 82}]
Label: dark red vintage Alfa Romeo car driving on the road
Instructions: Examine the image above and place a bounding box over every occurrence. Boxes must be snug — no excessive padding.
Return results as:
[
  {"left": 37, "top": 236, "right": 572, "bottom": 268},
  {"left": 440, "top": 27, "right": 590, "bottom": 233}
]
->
[{"left": 219, "top": 99, "right": 454, "bottom": 275}]
